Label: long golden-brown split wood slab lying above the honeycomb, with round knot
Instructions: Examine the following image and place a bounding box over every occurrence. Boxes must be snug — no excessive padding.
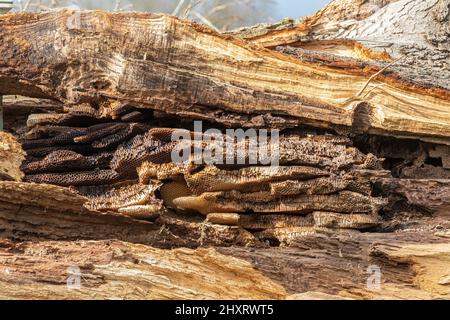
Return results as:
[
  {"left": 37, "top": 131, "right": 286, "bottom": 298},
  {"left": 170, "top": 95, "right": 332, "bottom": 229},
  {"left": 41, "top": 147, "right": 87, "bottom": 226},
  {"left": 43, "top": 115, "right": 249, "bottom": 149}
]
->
[{"left": 0, "top": 3, "right": 450, "bottom": 143}]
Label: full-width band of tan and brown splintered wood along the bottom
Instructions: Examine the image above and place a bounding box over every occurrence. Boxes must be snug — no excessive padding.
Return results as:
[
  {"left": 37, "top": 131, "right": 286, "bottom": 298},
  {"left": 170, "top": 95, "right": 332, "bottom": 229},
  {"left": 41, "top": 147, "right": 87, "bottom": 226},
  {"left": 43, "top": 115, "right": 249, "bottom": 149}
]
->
[{"left": 0, "top": 233, "right": 450, "bottom": 299}]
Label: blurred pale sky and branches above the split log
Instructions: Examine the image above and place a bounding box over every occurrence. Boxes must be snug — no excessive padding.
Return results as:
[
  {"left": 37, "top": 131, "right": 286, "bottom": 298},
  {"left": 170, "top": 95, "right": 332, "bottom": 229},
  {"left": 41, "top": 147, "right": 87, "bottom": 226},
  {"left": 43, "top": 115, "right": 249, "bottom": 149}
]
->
[{"left": 10, "top": 0, "right": 330, "bottom": 31}]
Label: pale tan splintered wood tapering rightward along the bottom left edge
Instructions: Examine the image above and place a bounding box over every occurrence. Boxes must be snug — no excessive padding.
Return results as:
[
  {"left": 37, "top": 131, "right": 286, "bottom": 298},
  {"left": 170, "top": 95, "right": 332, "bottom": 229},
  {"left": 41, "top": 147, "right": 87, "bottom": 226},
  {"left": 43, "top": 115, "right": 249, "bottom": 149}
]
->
[{"left": 0, "top": 240, "right": 286, "bottom": 299}]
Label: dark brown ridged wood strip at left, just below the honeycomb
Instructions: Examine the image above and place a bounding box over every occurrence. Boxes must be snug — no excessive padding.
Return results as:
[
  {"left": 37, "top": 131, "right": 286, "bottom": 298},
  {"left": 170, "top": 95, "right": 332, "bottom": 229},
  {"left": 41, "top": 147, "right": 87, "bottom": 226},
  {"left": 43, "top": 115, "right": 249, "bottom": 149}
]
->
[{"left": 0, "top": 181, "right": 258, "bottom": 248}]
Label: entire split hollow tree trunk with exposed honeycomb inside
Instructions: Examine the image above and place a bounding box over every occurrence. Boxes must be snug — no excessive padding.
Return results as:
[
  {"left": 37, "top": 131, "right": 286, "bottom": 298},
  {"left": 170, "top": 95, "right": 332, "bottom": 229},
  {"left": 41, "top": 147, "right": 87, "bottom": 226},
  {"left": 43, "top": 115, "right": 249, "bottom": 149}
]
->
[{"left": 0, "top": 0, "right": 450, "bottom": 299}]
